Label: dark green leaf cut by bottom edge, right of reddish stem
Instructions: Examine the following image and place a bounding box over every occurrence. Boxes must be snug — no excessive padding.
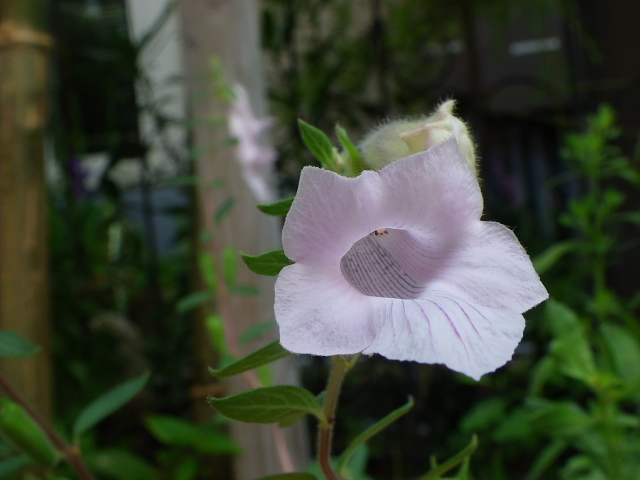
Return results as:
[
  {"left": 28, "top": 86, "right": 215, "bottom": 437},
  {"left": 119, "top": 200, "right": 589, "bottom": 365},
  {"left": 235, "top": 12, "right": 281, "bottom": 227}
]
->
[{"left": 83, "top": 448, "right": 159, "bottom": 480}]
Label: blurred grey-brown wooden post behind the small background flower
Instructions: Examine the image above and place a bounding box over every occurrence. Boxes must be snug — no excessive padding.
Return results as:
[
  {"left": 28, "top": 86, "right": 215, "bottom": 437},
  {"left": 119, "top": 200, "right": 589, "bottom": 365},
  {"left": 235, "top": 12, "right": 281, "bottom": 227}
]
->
[{"left": 180, "top": 0, "right": 307, "bottom": 480}]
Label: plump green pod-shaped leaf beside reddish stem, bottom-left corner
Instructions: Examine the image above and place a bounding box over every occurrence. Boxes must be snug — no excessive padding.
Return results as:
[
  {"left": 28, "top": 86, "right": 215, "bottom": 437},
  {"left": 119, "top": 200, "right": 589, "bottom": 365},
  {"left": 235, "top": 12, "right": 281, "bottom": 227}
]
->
[{"left": 0, "top": 398, "right": 60, "bottom": 467}]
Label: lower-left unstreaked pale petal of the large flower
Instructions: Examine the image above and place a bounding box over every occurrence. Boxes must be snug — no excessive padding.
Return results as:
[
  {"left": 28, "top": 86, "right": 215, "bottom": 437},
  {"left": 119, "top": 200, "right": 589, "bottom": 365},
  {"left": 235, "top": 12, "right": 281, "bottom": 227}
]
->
[{"left": 274, "top": 264, "right": 382, "bottom": 355}]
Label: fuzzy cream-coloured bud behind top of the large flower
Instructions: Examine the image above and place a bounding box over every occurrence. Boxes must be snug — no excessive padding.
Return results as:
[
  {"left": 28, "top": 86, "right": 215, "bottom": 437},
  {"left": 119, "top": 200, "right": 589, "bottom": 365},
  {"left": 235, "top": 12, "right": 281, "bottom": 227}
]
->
[{"left": 360, "top": 100, "right": 477, "bottom": 174}]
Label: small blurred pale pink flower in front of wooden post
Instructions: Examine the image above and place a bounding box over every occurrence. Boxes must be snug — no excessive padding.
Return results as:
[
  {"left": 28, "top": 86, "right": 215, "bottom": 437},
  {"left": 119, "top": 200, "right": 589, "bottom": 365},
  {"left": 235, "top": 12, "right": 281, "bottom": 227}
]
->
[{"left": 228, "top": 84, "right": 276, "bottom": 203}]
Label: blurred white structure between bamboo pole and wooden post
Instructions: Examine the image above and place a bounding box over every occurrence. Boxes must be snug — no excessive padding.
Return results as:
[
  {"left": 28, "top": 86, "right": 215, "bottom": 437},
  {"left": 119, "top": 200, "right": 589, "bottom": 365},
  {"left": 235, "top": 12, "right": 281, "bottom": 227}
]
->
[{"left": 110, "top": 0, "right": 187, "bottom": 188}]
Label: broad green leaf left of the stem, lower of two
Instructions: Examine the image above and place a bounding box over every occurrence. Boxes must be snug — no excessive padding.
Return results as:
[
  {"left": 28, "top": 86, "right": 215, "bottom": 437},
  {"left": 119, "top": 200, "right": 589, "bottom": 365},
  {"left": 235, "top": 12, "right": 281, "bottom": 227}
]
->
[{"left": 209, "top": 385, "right": 326, "bottom": 423}]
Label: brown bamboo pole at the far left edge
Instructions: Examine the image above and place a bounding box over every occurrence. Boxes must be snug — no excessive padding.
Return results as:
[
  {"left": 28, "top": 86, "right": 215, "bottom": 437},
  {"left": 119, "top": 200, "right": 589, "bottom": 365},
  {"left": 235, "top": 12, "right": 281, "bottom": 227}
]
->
[{"left": 0, "top": 0, "right": 51, "bottom": 417}]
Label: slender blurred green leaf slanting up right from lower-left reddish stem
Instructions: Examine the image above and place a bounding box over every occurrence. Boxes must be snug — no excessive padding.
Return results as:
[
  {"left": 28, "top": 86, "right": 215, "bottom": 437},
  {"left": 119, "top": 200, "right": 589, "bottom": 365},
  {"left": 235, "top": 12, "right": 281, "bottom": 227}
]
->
[{"left": 73, "top": 373, "right": 149, "bottom": 438}]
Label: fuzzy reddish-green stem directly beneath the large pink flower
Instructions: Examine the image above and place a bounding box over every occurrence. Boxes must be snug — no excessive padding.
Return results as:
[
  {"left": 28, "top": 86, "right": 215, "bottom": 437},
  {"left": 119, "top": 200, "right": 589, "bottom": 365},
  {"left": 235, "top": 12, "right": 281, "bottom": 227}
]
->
[{"left": 318, "top": 355, "right": 357, "bottom": 480}]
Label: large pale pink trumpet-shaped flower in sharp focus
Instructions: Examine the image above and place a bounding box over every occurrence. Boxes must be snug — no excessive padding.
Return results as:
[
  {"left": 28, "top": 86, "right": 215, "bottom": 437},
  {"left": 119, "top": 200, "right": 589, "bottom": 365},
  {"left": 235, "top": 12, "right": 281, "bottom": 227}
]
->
[{"left": 275, "top": 139, "right": 548, "bottom": 379}]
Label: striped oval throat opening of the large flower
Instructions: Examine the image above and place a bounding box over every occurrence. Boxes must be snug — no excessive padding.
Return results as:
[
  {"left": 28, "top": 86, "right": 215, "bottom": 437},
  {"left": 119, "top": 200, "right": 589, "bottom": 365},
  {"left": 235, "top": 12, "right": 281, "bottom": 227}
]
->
[{"left": 340, "top": 228, "right": 443, "bottom": 299}]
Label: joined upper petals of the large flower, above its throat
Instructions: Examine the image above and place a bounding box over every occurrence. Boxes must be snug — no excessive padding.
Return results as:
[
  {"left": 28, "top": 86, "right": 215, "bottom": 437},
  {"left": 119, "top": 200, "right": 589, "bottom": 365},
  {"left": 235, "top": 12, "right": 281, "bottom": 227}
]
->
[{"left": 282, "top": 138, "right": 482, "bottom": 265}]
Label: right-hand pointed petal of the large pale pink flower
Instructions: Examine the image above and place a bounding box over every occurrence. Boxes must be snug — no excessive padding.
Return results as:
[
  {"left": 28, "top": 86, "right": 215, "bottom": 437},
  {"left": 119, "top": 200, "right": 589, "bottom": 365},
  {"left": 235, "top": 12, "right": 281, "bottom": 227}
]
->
[{"left": 427, "top": 222, "right": 549, "bottom": 313}]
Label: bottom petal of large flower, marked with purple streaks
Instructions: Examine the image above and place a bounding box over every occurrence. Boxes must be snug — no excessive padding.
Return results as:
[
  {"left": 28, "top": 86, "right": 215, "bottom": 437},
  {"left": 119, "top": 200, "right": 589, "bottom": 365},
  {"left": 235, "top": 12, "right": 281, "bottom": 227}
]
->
[{"left": 363, "top": 295, "right": 524, "bottom": 380}]
